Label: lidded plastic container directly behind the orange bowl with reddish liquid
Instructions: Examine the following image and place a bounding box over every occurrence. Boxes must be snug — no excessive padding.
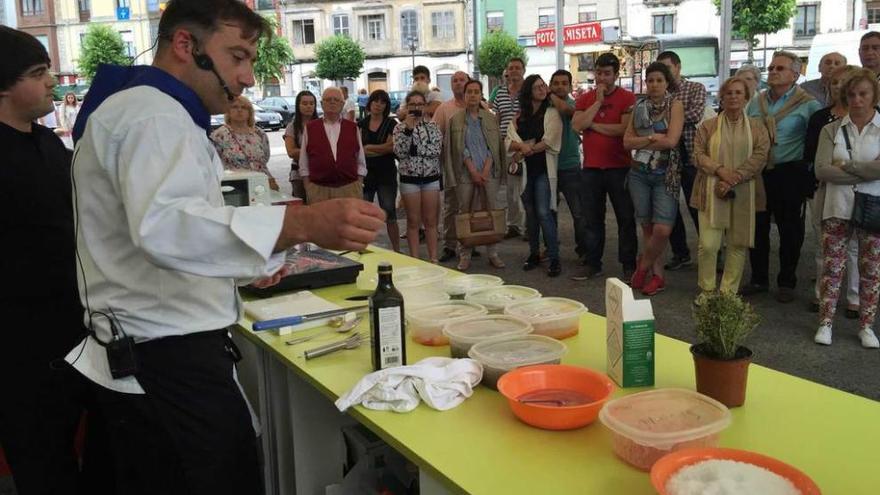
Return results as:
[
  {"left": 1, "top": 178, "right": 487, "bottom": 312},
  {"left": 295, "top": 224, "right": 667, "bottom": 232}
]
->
[{"left": 468, "top": 335, "right": 568, "bottom": 389}]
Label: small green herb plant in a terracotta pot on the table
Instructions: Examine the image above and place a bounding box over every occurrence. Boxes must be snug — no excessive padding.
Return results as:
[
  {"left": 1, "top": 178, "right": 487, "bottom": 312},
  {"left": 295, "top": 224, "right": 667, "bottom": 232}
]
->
[{"left": 691, "top": 292, "right": 761, "bottom": 407}]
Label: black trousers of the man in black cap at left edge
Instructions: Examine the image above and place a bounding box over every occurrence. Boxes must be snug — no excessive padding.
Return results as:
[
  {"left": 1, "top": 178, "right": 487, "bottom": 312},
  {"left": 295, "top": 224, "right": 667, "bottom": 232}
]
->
[{"left": 0, "top": 359, "right": 113, "bottom": 495}]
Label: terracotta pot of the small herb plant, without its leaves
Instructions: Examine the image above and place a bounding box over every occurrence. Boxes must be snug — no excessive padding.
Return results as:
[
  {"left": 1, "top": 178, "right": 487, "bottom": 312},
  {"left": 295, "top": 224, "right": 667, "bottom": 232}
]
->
[{"left": 691, "top": 344, "right": 752, "bottom": 407}]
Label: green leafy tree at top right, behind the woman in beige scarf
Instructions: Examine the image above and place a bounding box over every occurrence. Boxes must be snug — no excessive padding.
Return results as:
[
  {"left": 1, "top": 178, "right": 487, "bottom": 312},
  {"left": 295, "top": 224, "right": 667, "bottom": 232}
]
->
[{"left": 712, "top": 0, "right": 797, "bottom": 65}]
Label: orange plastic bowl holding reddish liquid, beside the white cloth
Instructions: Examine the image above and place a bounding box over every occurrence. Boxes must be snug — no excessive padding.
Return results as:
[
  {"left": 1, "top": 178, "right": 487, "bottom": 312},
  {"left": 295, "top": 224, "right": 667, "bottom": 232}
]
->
[{"left": 498, "top": 364, "right": 617, "bottom": 430}]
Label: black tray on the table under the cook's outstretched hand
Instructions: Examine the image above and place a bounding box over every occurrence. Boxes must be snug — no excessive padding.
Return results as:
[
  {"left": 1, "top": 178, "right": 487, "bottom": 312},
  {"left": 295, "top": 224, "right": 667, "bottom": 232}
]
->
[{"left": 241, "top": 248, "right": 364, "bottom": 297}]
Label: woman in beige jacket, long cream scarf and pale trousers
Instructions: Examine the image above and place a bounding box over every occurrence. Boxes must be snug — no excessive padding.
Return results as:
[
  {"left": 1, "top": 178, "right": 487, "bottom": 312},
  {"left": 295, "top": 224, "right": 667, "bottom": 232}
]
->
[{"left": 691, "top": 77, "right": 770, "bottom": 304}]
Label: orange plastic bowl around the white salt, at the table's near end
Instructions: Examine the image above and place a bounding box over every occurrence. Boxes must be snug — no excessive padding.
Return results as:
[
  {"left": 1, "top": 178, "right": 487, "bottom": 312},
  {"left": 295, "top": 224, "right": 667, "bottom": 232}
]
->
[{"left": 651, "top": 448, "right": 822, "bottom": 495}]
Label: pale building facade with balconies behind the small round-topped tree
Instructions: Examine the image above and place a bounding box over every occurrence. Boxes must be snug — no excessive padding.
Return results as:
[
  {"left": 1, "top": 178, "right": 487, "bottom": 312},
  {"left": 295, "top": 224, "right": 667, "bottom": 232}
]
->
[{"left": 281, "top": 0, "right": 471, "bottom": 97}]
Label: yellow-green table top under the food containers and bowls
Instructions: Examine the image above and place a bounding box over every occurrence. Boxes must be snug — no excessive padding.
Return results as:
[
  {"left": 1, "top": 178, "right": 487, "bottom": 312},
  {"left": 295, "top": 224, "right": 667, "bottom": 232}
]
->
[{"left": 239, "top": 248, "right": 880, "bottom": 495}]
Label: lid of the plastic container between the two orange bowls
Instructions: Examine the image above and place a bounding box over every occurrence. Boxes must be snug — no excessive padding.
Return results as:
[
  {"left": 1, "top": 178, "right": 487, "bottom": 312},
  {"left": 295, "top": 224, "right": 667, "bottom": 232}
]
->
[{"left": 599, "top": 388, "right": 730, "bottom": 450}]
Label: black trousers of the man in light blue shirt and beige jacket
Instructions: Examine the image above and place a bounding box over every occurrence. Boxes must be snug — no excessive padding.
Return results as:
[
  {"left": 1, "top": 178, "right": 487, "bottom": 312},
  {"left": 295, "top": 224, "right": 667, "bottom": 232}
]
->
[{"left": 749, "top": 162, "right": 811, "bottom": 289}]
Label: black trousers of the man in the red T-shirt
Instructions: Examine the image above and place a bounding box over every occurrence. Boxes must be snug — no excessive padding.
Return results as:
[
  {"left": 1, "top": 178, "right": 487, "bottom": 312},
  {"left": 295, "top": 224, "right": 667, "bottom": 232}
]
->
[{"left": 581, "top": 168, "right": 639, "bottom": 270}]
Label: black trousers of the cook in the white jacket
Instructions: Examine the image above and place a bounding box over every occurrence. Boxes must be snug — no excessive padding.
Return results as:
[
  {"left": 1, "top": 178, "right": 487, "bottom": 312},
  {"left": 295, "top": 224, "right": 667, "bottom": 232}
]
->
[{"left": 95, "top": 330, "right": 262, "bottom": 495}]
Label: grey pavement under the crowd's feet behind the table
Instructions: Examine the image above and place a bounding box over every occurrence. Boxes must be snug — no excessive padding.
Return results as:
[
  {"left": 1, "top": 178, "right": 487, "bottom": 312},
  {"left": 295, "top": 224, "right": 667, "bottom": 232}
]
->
[{"left": 270, "top": 132, "right": 880, "bottom": 400}]
